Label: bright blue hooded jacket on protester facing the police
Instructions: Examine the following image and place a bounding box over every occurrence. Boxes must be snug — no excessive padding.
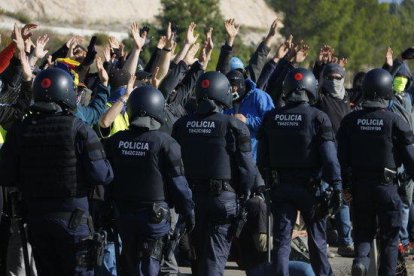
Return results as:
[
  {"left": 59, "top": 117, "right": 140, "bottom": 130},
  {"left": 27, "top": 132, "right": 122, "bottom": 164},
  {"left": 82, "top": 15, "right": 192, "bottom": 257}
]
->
[{"left": 224, "top": 79, "right": 275, "bottom": 162}]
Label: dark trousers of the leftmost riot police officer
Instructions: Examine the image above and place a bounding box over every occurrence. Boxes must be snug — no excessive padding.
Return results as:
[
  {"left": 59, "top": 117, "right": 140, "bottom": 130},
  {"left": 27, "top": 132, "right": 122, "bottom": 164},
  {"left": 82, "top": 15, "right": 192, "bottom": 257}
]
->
[{"left": 27, "top": 217, "right": 94, "bottom": 276}]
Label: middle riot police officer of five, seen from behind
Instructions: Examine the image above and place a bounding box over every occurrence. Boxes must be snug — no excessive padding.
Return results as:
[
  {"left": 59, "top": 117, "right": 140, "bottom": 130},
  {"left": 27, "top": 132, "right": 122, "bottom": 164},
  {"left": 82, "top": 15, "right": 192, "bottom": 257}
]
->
[{"left": 173, "top": 72, "right": 255, "bottom": 276}]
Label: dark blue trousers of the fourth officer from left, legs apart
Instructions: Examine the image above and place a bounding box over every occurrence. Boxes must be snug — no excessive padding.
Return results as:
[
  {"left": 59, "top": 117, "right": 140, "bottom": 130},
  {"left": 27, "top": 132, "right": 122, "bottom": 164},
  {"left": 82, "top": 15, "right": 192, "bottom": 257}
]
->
[{"left": 272, "top": 183, "right": 333, "bottom": 275}]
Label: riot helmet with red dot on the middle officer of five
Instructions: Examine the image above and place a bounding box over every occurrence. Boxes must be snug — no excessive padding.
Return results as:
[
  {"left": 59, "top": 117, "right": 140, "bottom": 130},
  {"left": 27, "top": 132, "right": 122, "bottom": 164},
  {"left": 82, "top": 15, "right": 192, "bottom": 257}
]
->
[{"left": 195, "top": 72, "right": 232, "bottom": 108}]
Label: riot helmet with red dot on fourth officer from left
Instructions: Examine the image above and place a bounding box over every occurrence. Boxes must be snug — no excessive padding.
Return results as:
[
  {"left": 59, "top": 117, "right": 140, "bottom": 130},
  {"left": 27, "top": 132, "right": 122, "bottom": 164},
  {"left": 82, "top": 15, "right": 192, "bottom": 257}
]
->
[{"left": 283, "top": 68, "right": 318, "bottom": 102}]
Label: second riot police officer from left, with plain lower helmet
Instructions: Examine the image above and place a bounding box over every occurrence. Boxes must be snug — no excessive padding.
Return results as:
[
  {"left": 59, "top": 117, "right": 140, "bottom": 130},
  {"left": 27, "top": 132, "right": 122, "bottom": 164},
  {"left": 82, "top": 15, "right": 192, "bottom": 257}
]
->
[{"left": 105, "top": 86, "right": 195, "bottom": 276}]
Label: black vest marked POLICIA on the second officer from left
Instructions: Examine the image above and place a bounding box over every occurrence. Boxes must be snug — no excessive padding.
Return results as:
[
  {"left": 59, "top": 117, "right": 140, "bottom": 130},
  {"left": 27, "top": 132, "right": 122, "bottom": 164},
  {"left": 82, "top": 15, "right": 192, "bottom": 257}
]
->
[{"left": 108, "top": 129, "right": 171, "bottom": 203}]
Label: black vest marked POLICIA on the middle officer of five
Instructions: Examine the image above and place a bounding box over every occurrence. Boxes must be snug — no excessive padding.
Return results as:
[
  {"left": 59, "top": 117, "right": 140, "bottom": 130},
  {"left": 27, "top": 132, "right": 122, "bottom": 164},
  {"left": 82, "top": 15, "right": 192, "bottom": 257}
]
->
[{"left": 174, "top": 113, "right": 236, "bottom": 180}]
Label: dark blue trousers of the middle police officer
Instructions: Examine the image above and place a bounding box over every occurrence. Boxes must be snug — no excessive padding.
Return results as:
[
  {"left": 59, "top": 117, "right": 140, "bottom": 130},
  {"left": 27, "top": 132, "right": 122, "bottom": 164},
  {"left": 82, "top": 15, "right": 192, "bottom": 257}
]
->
[{"left": 191, "top": 191, "right": 237, "bottom": 276}]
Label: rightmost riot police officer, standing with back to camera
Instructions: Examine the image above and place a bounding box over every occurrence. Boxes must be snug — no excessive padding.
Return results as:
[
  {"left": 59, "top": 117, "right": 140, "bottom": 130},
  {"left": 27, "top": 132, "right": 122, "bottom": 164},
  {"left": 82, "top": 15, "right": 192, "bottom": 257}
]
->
[{"left": 337, "top": 69, "right": 414, "bottom": 275}]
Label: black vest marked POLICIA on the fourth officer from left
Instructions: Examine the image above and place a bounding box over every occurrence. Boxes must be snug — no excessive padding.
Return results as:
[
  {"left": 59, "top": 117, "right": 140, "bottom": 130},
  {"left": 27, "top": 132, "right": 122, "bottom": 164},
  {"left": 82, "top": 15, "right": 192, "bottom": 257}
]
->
[{"left": 265, "top": 104, "right": 321, "bottom": 169}]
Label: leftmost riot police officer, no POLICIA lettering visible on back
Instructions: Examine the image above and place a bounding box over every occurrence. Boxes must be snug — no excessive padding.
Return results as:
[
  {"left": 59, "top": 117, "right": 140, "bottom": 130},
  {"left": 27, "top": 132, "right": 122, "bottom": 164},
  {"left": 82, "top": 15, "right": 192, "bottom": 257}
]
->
[{"left": 0, "top": 68, "right": 113, "bottom": 275}]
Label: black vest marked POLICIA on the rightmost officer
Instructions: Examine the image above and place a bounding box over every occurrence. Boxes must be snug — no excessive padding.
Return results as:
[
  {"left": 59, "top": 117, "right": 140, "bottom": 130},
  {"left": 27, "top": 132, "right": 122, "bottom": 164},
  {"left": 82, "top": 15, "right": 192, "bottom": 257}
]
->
[{"left": 346, "top": 110, "right": 400, "bottom": 171}]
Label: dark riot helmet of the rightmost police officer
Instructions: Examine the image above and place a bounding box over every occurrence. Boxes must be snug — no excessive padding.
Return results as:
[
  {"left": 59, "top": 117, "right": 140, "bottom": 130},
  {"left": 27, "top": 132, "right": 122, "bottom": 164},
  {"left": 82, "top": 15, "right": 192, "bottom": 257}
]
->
[{"left": 362, "top": 68, "right": 393, "bottom": 101}]
